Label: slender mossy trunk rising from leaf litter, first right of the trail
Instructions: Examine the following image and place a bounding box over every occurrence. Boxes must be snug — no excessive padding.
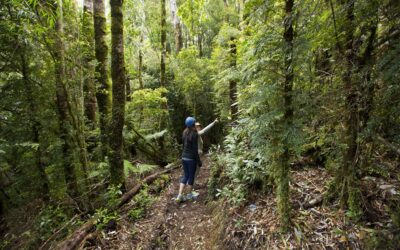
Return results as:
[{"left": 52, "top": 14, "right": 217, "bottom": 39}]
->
[{"left": 277, "top": 0, "right": 294, "bottom": 231}]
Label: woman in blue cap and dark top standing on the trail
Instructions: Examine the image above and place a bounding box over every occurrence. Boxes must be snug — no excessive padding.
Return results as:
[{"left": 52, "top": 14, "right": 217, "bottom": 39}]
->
[{"left": 176, "top": 117, "right": 202, "bottom": 202}]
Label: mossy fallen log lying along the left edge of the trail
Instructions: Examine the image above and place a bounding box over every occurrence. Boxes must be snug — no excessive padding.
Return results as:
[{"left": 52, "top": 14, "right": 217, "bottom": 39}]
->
[{"left": 57, "top": 162, "right": 179, "bottom": 250}]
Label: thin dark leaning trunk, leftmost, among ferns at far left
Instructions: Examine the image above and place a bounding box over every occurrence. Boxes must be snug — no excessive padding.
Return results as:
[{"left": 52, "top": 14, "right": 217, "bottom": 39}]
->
[{"left": 21, "top": 52, "right": 50, "bottom": 201}]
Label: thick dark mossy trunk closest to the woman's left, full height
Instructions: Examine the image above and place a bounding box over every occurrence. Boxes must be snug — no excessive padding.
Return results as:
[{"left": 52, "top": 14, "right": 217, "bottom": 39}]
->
[{"left": 109, "top": 0, "right": 125, "bottom": 190}]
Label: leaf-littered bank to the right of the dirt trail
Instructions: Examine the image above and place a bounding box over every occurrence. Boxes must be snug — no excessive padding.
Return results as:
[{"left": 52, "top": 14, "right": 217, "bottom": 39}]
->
[{"left": 215, "top": 168, "right": 400, "bottom": 249}]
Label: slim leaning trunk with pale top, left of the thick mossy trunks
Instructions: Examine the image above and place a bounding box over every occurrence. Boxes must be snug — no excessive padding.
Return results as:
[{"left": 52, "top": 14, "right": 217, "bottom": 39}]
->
[{"left": 54, "top": 0, "right": 79, "bottom": 199}]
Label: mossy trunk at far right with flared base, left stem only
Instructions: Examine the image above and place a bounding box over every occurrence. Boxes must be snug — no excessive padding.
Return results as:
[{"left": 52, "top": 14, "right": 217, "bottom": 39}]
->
[{"left": 328, "top": 0, "right": 362, "bottom": 217}]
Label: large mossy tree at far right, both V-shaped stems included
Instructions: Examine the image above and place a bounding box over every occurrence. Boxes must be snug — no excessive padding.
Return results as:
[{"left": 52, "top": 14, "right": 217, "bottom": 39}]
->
[{"left": 330, "top": 0, "right": 378, "bottom": 217}]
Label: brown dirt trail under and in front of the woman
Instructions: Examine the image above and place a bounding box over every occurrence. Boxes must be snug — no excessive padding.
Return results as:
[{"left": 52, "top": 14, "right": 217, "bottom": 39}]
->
[{"left": 126, "top": 157, "right": 211, "bottom": 249}]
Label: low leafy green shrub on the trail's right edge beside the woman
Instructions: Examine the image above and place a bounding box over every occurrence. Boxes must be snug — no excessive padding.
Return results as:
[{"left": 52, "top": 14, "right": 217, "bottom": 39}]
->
[{"left": 209, "top": 120, "right": 271, "bottom": 205}]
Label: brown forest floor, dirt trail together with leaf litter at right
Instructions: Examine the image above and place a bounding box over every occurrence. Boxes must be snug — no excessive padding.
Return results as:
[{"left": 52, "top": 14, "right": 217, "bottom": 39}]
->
[{"left": 87, "top": 155, "right": 400, "bottom": 250}]
